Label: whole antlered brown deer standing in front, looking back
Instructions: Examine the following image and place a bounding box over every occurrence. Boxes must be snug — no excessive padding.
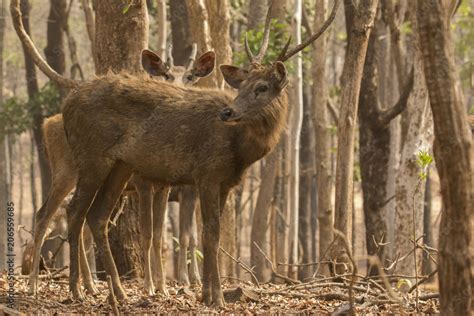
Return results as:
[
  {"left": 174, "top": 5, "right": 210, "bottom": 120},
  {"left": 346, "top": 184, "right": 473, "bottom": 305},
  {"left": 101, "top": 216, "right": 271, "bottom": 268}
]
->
[{"left": 10, "top": 0, "right": 338, "bottom": 307}]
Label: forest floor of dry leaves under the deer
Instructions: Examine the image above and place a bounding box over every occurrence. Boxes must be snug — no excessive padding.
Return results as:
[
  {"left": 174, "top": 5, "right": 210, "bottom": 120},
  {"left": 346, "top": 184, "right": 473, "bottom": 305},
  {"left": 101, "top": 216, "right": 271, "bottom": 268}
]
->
[{"left": 0, "top": 274, "right": 439, "bottom": 315}]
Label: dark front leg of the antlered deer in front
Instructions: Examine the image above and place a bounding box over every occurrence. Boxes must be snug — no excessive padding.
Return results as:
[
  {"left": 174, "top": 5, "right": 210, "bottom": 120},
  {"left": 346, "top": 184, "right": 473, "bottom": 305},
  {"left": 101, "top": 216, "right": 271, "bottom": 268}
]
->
[{"left": 199, "top": 182, "right": 224, "bottom": 307}]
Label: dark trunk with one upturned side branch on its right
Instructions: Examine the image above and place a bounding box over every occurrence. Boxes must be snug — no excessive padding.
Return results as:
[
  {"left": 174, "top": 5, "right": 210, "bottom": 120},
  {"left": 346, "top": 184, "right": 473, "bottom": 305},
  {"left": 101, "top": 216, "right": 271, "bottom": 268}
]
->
[{"left": 358, "top": 8, "right": 413, "bottom": 275}]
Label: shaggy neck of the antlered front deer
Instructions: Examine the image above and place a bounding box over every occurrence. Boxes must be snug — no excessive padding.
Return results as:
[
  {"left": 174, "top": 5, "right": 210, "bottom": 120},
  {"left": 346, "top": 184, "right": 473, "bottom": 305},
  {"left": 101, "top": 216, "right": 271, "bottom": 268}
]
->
[{"left": 240, "top": 93, "right": 288, "bottom": 166}]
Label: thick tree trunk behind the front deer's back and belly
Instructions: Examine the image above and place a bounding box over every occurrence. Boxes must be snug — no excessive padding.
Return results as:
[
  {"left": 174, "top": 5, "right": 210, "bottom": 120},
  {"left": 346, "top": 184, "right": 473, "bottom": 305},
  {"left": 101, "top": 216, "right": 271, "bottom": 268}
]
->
[{"left": 95, "top": 0, "right": 148, "bottom": 277}]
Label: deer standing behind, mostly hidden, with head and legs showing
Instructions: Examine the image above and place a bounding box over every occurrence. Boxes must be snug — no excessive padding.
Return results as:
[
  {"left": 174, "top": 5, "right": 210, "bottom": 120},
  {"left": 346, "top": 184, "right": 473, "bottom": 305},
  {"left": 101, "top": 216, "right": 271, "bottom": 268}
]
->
[{"left": 24, "top": 45, "right": 215, "bottom": 295}]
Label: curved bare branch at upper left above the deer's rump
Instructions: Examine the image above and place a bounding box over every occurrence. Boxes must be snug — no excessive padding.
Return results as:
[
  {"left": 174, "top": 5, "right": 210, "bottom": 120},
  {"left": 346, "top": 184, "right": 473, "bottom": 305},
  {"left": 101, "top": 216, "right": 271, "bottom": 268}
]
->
[{"left": 10, "top": 0, "right": 80, "bottom": 88}]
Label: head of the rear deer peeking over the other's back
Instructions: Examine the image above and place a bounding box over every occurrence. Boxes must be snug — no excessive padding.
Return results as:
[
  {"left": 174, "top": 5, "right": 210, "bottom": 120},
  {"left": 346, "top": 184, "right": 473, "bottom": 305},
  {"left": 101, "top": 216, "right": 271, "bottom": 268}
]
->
[{"left": 141, "top": 44, "right": 216, "bottom": 85}]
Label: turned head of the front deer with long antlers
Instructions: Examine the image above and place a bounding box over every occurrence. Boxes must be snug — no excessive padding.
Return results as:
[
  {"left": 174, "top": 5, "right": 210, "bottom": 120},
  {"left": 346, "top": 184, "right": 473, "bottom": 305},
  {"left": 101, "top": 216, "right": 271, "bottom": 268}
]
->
[{"left": 220, "top": 0, "right": 339, "bottom": 123}]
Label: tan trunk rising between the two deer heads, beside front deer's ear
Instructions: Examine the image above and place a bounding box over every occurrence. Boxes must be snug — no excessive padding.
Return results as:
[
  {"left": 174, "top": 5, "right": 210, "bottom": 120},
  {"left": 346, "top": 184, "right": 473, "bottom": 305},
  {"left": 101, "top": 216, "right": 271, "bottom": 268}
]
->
[{"left": 206, "top": 0, "right": 232, "bottom": 89}]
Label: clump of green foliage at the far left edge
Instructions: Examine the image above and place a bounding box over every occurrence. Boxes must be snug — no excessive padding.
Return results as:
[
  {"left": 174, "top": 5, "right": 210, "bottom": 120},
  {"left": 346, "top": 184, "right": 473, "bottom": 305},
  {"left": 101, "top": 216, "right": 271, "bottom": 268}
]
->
[{"left": 0, "top": 97, "right": 32, "bottom": 137}]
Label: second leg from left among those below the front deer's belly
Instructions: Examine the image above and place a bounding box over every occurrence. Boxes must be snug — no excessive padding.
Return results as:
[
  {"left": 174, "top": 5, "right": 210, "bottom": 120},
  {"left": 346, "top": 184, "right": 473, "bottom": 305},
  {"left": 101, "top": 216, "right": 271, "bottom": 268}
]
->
[{"left": 153, "top": 185, "right": 170, "bottom": 295}]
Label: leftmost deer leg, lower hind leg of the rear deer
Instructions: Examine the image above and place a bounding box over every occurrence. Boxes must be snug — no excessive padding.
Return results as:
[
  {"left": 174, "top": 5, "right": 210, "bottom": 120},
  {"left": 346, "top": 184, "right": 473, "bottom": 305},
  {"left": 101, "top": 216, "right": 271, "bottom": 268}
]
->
[{"left": 28, "top": 176, "right": 76, "bottom": 295}]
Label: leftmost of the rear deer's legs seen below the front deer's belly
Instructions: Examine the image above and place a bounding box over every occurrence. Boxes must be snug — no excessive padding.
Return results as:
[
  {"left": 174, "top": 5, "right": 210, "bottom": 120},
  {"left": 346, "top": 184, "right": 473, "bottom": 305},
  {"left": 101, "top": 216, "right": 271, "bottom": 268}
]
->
[{"left": 134, "top": 176, "right": 155, "bottom": 296}]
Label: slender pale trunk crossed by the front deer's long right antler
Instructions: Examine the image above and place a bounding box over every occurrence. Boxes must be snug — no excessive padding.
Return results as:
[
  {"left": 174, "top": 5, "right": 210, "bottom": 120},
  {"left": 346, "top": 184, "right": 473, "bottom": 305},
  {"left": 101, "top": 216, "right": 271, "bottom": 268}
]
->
[{"left": 312, "top": 0, "right": 334, "bottom": 275}]
